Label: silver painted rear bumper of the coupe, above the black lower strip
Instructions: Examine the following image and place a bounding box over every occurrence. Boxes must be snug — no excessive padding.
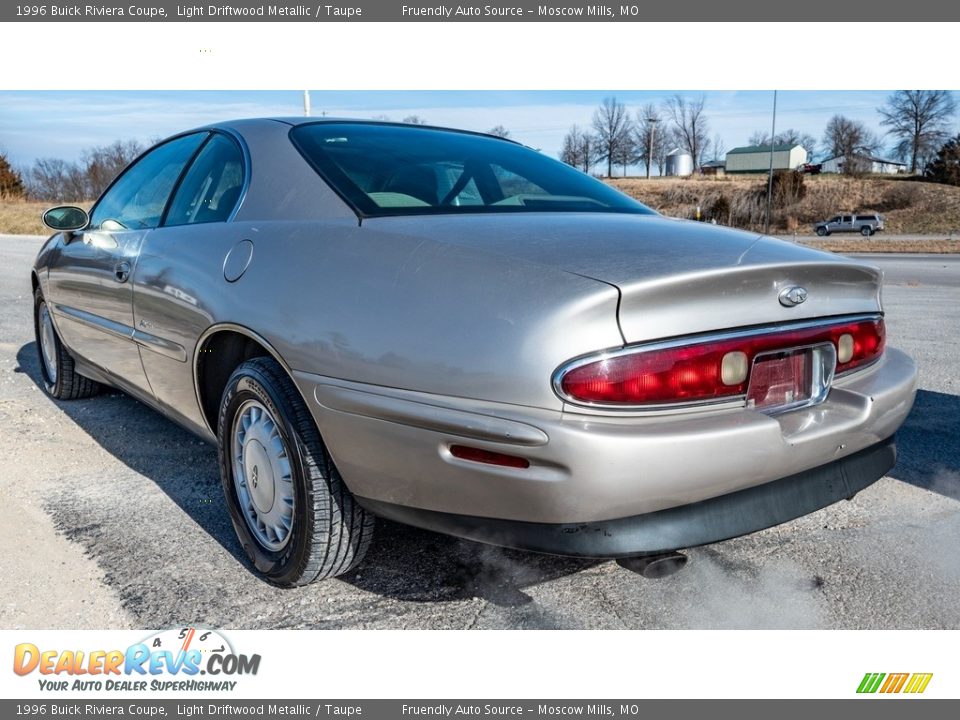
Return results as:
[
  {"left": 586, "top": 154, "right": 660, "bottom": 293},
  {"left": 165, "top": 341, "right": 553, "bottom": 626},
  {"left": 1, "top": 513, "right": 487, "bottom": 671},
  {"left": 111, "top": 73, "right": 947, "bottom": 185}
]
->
[{"left": 294, "top": 348, "right": 917, "bottom": 526}]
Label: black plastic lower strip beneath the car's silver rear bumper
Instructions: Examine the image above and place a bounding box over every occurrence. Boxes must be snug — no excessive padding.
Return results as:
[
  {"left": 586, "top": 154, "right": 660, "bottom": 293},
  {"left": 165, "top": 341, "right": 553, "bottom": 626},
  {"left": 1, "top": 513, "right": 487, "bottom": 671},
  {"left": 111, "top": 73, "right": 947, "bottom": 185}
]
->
[{"left": 359, "top": 438, "right": 897, "bottom": 558}]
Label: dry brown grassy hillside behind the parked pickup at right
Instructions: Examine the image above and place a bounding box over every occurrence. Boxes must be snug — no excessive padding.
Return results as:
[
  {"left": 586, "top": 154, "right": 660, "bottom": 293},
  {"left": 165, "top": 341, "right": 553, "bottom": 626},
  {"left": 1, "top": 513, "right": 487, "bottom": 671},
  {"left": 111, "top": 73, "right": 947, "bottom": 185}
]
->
[{"left": 609, "top": 175, "right": 960, "bottom": 235}]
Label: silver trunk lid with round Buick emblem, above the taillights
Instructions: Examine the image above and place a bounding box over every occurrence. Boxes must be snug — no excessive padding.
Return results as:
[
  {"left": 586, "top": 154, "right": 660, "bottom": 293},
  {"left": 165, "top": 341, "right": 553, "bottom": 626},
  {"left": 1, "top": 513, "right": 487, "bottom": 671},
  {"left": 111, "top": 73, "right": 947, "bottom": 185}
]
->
[{"left": 364, "top": 213, "right": 880, "bottom": 343}]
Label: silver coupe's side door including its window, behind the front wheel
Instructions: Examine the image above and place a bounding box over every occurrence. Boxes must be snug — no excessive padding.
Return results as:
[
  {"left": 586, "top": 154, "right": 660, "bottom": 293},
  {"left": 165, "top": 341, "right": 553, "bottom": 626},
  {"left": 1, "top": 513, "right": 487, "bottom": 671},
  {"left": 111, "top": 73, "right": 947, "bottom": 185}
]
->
[{"left": 49, "top": 133, "right": 206, "bottom": 396}]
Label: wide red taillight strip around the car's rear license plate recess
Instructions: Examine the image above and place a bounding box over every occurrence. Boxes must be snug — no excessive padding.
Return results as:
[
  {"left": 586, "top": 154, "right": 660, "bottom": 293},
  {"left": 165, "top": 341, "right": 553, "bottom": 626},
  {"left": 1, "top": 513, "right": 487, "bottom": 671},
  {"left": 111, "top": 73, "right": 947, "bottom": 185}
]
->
[{"left": 558, "top": 318, "right": 885, "bottom": 405}]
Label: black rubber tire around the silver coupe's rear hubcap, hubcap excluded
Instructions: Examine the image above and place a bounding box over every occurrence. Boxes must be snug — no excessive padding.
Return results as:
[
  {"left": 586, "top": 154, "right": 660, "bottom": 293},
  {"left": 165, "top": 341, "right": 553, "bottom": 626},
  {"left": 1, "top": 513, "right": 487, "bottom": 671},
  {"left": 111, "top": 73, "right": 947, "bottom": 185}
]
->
[{"left": 217, "top": 357, "right": 374, "bottom": 587}]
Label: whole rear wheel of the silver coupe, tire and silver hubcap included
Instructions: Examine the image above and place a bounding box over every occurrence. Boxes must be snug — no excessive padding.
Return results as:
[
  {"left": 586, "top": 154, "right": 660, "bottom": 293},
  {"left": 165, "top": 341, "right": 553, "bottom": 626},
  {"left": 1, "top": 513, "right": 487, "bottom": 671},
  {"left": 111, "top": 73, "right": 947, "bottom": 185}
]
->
[{"left": 217, "top": 358, "right": 374, "bottom": 587}]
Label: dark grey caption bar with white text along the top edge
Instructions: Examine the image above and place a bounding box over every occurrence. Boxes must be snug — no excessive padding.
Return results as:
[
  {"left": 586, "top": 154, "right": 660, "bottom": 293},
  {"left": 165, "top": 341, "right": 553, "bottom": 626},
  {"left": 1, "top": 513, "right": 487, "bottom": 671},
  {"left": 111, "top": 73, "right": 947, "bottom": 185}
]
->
[{"left": 0, "top": 0, "right": 960, "bottom": 21}]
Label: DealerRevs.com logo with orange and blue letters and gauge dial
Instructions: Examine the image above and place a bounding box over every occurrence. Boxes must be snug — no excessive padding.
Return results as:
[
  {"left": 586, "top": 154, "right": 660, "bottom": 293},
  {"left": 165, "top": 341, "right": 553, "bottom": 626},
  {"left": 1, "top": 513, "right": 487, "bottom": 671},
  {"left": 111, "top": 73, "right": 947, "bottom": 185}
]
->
[{"left": 13, "top": 627, "right": 260, "bottom": 692}]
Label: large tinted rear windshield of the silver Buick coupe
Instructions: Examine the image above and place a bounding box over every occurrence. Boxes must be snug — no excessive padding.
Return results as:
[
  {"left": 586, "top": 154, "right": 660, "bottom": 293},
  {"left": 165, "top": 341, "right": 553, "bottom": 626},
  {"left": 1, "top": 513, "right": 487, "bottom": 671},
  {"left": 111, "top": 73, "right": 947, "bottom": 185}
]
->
[{"left": 290, "top": 122, "right": 654, "bottom": 216}]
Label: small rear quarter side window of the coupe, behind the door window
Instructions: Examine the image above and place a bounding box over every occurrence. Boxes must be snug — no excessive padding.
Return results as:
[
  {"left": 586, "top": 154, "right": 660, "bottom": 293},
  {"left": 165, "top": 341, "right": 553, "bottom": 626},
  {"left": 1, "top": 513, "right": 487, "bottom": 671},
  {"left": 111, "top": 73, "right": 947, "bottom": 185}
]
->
[{"left": 163, "top": 134, "right": 243, "bottom": 226}]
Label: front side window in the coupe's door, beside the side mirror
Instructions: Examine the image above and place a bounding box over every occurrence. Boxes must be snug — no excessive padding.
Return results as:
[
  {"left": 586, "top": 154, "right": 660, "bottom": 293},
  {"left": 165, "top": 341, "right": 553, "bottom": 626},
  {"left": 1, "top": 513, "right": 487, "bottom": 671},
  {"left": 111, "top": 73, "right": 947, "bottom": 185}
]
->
[{"left": 90, "top": 133, "right": 207, "bottom": 230}]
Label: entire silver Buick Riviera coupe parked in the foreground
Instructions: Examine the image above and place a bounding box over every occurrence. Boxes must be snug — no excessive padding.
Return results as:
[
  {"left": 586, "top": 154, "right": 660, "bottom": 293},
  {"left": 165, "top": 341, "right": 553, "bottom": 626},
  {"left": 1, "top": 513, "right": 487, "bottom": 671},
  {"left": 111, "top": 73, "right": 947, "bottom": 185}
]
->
[{"left": 31, "top": 118, "right": 916, "bottom": 585}]
